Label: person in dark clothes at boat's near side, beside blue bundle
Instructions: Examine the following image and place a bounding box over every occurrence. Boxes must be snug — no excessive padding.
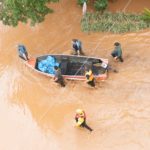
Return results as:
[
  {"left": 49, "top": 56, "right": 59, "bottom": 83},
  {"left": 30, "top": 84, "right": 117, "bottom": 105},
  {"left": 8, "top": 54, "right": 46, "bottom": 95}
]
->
[{"left": 54, "top": 66, "right": 65, "bottom": 87}]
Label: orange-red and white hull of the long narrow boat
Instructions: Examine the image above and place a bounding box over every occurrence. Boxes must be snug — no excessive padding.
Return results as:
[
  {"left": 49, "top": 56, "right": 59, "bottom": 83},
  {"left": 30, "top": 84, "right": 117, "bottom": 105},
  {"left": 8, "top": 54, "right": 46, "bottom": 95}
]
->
[{"left": 21, "top": 54, "right": 108, "bottom": 80}]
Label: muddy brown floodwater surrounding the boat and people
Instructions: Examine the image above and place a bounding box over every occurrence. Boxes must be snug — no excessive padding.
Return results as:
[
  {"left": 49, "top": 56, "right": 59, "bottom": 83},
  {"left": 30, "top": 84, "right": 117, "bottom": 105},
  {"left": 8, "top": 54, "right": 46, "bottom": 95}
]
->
[{"left": 0, "top": 0, "right": 150, "bottom": 150}]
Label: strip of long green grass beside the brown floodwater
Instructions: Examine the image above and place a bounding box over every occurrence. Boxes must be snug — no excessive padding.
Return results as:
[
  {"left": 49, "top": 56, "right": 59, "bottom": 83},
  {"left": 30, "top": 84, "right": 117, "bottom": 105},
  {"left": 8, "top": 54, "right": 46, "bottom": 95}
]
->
[{"left": 81, "top": 12, "right": 150, "bottom": 33}]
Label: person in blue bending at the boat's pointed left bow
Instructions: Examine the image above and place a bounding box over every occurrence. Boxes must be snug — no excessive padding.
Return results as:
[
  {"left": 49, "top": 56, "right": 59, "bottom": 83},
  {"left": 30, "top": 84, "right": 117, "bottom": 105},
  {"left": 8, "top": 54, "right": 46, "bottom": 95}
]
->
[{"left": 18, "top": 45, "right": 29, "bottom": 61}]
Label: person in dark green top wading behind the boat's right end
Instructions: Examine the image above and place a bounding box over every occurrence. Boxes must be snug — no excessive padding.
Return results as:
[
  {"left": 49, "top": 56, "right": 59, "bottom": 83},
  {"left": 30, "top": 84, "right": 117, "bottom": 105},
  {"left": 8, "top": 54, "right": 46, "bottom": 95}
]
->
[{"left": 111, "top": 42, "right": 123, "bottom": 62}]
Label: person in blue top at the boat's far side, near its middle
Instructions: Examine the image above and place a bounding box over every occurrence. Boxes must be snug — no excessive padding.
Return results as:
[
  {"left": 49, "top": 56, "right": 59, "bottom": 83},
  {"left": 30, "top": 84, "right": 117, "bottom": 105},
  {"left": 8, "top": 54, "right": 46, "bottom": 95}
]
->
[{"left": 72, "top": 39, "right": 83, "bottom": 55}]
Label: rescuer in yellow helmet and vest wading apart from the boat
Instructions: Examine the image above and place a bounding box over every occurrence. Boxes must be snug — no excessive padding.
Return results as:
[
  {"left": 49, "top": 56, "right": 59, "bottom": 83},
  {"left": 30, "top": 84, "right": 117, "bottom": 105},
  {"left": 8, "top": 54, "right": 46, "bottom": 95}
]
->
[{"left": 75, "top": 109, "right": 93, "bottom": 131}]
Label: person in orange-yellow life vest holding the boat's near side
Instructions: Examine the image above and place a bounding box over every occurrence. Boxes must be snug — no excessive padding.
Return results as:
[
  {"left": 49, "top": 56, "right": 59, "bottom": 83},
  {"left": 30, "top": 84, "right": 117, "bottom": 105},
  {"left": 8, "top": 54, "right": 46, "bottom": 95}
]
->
[{"left": 85, "top": 69, "right": 95, "bottom": 87}]
